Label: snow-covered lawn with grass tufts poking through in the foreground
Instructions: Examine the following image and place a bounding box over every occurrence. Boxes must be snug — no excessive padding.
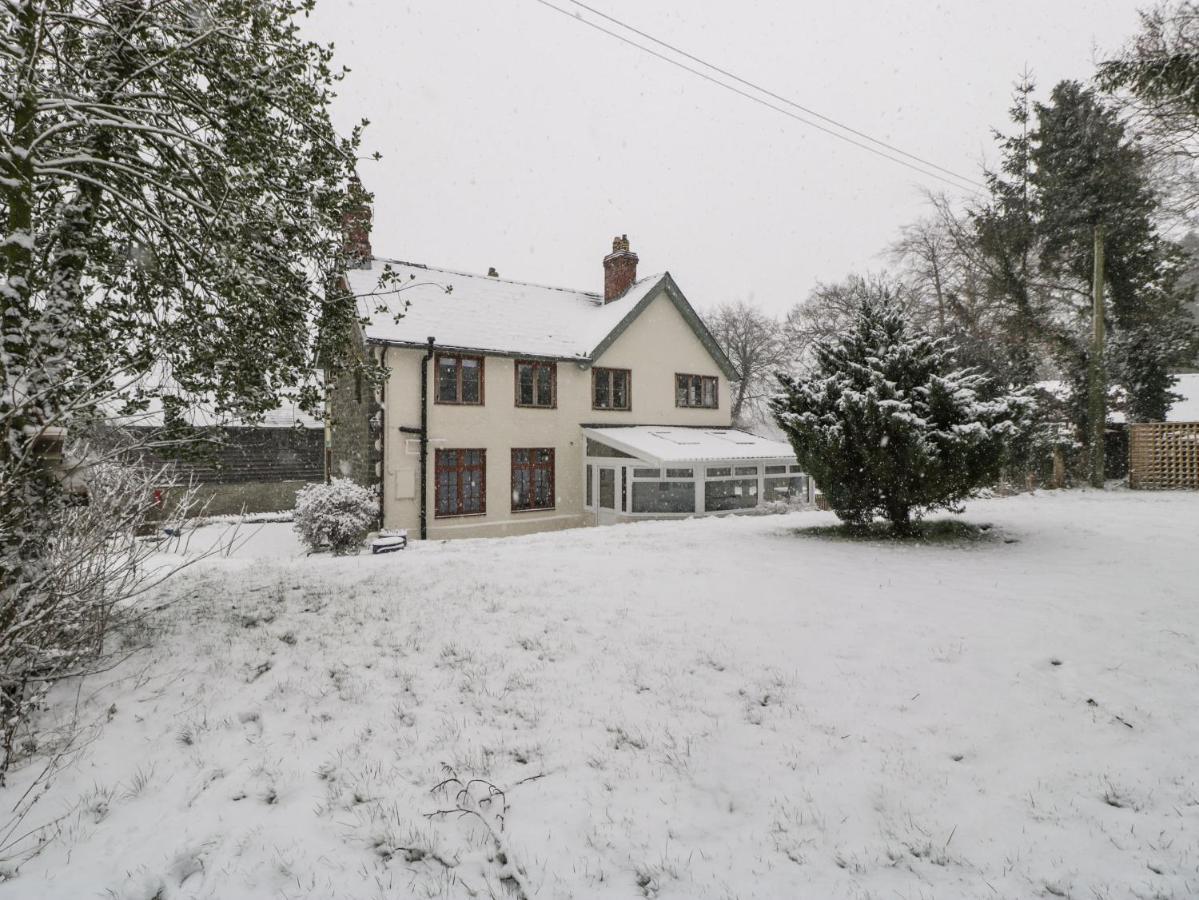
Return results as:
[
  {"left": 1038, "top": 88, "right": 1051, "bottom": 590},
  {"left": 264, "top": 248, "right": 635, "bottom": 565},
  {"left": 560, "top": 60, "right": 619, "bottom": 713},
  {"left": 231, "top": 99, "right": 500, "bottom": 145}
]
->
[{"left": 0, "top": 491, "right": 1199, "bottom": 900}]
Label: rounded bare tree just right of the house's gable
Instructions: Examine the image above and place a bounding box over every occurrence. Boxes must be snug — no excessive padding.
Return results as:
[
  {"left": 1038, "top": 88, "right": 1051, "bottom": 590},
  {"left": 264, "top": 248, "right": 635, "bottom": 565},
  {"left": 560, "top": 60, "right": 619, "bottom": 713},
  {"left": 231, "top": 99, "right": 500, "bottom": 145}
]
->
[{"left": 707, "top": 301, "right": 793, "bottom": 425}]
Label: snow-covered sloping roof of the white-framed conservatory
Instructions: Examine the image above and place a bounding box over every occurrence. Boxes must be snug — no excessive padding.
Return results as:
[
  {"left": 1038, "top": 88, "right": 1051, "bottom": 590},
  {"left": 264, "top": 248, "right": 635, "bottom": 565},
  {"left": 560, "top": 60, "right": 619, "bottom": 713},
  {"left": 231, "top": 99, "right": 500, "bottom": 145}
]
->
[{"left": 583, "top": 425, "right": 795, "bottom": 466}]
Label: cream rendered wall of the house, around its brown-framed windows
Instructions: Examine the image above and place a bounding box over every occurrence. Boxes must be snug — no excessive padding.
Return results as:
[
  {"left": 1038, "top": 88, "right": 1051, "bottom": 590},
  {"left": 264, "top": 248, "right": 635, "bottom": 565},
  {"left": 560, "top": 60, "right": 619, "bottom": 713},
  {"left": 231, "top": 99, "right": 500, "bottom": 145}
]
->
[{"left": 382, "top": 294, "right": 730, "bottom": 538}]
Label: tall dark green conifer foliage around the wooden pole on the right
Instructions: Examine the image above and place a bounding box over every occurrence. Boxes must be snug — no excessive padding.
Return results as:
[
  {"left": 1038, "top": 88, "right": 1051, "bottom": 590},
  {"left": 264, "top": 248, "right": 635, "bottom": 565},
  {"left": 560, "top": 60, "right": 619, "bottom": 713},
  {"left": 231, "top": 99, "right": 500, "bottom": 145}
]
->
[{"left": 974, "top": 79, "right": 1194, "bottom": 464}]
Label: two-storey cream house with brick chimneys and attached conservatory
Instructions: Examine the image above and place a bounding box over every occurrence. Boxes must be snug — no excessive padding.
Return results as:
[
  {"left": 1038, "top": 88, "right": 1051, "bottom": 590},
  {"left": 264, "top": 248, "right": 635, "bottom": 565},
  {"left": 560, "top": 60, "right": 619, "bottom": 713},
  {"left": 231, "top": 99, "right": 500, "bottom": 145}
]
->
[{"left": 329, "top": 219, "right": 811, "bottom": 538}]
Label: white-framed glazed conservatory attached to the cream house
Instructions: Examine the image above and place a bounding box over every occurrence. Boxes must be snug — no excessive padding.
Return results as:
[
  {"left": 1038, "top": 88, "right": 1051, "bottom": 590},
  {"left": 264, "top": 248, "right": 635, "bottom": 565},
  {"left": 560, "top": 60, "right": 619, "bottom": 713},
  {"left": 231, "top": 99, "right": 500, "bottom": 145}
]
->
[{"left": 583, "top": 425, "right": 813, "bottom": 525}]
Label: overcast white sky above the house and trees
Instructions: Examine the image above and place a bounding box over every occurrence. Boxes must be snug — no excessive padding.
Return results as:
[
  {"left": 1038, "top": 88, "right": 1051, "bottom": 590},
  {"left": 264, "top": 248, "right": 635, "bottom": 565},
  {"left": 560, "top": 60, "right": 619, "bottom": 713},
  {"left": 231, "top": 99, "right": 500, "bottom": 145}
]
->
[{"left": 307, "top": 0, "right": 1145, "bottom": 313}]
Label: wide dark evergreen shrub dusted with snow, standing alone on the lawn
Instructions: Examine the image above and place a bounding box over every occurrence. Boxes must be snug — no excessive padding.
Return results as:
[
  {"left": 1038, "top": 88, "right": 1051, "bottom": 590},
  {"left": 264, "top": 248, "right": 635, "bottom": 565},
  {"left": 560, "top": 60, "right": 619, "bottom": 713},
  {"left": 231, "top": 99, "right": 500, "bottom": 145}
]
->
[{"left": 771, "top": 297, "right": 1032, "bottom": 532}]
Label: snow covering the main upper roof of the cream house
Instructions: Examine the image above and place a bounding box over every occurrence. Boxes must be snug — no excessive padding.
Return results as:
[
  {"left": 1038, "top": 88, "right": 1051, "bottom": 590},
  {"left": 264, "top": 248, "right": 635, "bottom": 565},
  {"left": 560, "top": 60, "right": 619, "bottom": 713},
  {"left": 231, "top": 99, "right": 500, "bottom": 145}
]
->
[{"left": 348, "top": 258, "right": 667, "bottom": 360}]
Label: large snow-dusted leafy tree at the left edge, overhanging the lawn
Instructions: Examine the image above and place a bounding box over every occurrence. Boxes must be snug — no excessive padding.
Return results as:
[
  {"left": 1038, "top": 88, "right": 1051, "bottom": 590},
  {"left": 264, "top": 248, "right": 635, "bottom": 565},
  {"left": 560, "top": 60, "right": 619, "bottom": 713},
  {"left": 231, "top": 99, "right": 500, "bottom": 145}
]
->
[{"left": 0, "top": 0, "right": 359, "bottom": 776}]
